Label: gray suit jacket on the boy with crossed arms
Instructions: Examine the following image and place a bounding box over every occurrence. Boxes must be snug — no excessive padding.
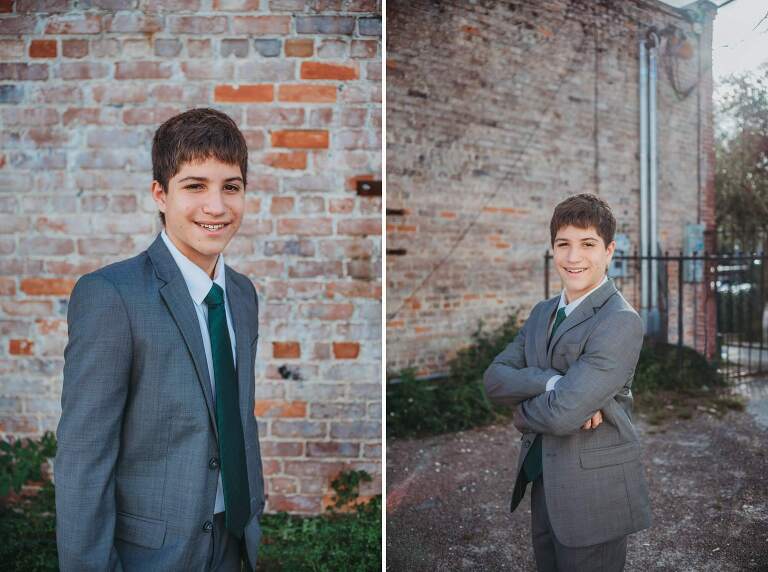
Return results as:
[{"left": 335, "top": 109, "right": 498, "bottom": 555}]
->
[{"left": 484, "top": 280, "right": 651, "bottom": 547}]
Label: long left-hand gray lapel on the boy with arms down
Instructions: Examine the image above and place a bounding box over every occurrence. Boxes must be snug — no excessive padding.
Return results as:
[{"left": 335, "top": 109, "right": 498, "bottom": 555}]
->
[{"left": 147, "top": 235, "right": 219, "bottom": 440}]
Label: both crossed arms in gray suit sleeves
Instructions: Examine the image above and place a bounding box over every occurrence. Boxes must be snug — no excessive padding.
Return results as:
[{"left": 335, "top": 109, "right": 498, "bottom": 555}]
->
[{"left": 483, "top": 310, "right": 643, "bottom": 435}]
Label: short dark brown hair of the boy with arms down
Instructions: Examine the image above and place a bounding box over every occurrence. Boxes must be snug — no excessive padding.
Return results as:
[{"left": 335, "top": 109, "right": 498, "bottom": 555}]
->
[{"left": 152, "top": 108, "right": 248, "bottom": 226}]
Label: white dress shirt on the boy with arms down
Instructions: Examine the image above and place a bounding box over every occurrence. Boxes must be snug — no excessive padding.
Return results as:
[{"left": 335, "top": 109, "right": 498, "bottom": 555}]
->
[{"left": 161, "top": 229, "right": 237, "bottom": 514}]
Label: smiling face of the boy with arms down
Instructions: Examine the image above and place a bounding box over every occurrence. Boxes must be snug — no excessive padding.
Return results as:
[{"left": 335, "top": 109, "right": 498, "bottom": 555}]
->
[{"left": 152, "top": 158, "right": 245, "bottom": 276}]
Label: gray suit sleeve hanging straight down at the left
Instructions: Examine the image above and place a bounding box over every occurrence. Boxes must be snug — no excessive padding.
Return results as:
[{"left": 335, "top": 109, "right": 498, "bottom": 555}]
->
[{"left": 54, "top": 274, "right": 132, "bottom": 572}]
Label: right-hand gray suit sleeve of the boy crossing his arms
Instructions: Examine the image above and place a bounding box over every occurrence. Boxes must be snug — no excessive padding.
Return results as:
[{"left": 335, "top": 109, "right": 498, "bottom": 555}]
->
[{"left": 516, "top": 310, "right": 643, "bottom": 435}]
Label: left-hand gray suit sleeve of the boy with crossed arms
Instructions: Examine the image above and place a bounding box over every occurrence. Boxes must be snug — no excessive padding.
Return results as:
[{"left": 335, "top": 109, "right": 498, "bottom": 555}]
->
[{"left": 483, "top": 312, "right": 560, "bottom": 406}]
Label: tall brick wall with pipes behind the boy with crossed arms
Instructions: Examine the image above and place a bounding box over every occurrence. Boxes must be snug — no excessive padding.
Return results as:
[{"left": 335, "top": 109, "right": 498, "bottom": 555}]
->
[{"left": 386, "top": 0, "right": 714, "bottom": 374}]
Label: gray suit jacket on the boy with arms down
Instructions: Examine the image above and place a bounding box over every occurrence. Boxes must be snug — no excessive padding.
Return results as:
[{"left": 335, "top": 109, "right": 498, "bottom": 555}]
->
[{"left": 54, "top": 236, "right": 264, "bottom": 572}]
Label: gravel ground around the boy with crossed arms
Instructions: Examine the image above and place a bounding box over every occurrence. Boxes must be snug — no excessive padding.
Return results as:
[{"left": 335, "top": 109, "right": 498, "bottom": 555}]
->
[{"left": 387, "top": 384, "right": 768, "bottom": 572}]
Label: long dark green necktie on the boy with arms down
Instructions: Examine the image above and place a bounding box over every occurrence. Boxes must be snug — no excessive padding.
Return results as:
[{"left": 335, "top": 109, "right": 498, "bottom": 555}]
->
[{"left": 205, "top": 283, "right": 250, "bottom": 538}]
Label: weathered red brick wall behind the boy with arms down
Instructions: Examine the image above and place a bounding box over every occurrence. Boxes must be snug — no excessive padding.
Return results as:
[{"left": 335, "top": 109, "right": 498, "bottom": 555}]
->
[{"left": 0, "top": 0, "right": 382, "bottom": 513}]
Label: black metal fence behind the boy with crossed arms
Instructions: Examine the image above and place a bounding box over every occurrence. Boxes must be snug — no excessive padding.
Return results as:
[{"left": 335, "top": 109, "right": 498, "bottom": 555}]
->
[{"left": 544, "top": 252, "right": 768, "bottom": 381}]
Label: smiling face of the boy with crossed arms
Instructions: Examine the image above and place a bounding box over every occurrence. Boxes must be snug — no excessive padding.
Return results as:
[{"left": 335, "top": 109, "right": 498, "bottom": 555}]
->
[{"left": 553, "top": 225, "right": 616, "bottom": 304}]
